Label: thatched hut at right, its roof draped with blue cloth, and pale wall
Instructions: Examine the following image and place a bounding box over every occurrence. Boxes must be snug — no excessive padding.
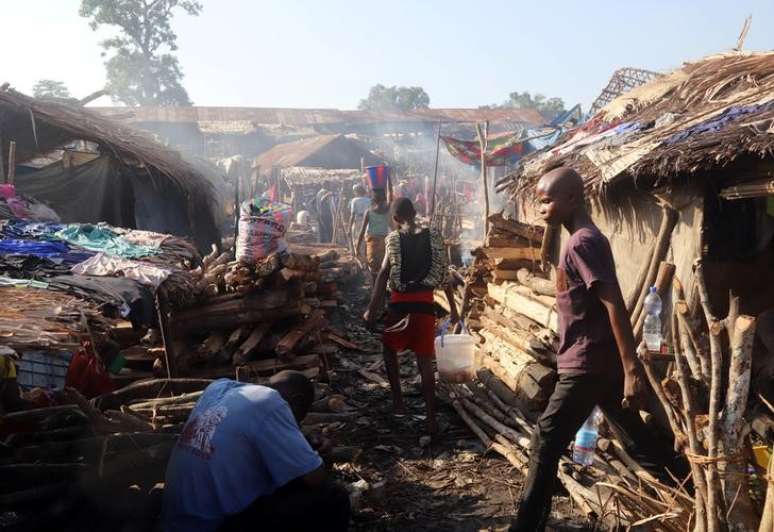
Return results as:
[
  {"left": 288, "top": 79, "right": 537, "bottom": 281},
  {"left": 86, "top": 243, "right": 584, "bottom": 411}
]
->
[{"left": 499, "top": 52, "right": 774, "bottom": 324}]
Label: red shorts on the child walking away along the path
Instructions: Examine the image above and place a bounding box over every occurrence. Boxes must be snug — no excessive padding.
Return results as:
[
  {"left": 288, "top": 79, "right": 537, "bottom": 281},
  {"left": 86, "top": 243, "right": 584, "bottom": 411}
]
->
[{"left": 382, "top": 290, "right": 435, "bottom": 357}]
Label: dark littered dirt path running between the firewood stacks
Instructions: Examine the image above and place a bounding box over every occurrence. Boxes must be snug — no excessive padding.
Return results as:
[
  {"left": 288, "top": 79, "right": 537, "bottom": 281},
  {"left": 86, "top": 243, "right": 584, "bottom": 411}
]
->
[{"left": 326, "top": 280, "right": 586, "bottom": 531}]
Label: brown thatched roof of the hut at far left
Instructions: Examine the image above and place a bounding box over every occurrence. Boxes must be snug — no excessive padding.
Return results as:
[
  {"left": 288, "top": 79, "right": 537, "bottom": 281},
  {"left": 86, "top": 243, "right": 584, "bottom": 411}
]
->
[{"left": 0, "top": 88, "right": 212, "bottom": 204}]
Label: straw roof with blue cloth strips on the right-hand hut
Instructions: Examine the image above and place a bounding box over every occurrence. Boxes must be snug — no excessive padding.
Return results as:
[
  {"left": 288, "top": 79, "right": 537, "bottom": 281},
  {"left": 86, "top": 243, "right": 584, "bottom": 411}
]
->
[{"left": 500, "top": 52, "right": 774, "bottom": 201}]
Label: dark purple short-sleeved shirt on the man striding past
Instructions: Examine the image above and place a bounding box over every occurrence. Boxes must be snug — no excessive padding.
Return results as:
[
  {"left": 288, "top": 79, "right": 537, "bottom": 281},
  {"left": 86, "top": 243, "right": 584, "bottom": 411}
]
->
[{"left": 556, "top": 226, "right": 620, "bottom": 373}]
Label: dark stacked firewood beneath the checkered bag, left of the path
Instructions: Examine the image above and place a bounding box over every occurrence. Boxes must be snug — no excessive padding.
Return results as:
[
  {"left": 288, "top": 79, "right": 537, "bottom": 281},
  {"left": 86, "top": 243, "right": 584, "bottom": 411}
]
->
[{"left": 165, "top": 245, "right": 356, "bottom": 372}]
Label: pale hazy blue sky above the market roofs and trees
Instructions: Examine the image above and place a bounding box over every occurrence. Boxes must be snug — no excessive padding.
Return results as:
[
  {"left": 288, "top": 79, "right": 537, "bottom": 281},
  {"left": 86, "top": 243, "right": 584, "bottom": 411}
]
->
[{"left": 6, "top": 0, "right": 774, "bottom": 109}]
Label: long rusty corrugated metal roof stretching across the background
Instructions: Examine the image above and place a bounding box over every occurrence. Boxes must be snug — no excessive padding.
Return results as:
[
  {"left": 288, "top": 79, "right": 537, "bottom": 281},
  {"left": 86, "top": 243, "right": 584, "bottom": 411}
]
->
[{"left": 91, "top": 107, "right": 546, "bottom": 126}]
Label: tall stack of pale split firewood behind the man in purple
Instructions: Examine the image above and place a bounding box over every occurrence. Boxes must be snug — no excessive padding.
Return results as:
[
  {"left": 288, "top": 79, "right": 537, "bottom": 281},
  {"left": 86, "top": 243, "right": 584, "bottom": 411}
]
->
[{"left": 446, "top": 214, "right": 557, "bottom": 418}]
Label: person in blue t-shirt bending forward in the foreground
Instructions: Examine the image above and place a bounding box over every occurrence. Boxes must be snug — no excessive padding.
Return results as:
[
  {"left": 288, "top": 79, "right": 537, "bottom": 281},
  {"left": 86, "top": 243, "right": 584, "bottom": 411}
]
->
[{"left": 164, "top": 371, "right": 350, "bottom": 532}]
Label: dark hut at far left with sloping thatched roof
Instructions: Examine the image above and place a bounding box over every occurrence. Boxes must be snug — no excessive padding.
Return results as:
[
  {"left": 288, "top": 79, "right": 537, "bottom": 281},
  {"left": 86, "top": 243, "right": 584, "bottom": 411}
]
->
[{"left": 0, "top": 87, "right": 219, "bottom": 249}]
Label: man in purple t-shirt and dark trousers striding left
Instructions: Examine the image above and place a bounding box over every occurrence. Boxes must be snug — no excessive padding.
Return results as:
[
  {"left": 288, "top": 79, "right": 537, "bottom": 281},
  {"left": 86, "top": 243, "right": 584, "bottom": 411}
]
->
[{"left": 510, "top": 167, "right": 672, "bottom": 532}]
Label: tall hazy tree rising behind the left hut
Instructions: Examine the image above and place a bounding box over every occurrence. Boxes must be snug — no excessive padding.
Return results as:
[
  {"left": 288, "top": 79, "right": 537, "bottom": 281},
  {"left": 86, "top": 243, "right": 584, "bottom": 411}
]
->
[{"left": 80, "top": 0, "right": 202, "bottom": 106}]
